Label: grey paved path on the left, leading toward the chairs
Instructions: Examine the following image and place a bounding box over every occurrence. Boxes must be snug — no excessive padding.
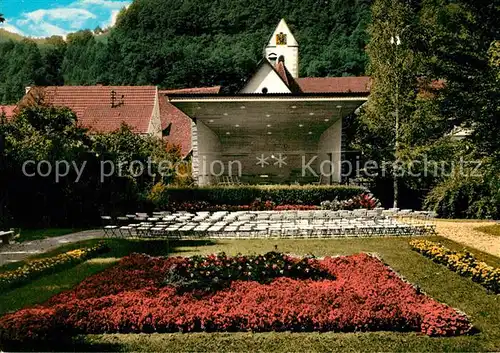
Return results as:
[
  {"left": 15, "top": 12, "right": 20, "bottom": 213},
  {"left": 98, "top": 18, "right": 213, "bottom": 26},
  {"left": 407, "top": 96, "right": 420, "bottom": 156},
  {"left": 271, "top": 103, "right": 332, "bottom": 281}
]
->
[{"left": 0, "top": 230, "right": 104, "bottom": 266}]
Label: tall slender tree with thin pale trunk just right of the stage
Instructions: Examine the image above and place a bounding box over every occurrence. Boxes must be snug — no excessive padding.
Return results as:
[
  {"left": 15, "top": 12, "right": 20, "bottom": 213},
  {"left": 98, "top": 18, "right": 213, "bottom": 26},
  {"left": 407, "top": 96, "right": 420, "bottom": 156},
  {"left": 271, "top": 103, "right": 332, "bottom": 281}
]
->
[{"left": 363, "top": 0, "right": 419, "bottom": 207}]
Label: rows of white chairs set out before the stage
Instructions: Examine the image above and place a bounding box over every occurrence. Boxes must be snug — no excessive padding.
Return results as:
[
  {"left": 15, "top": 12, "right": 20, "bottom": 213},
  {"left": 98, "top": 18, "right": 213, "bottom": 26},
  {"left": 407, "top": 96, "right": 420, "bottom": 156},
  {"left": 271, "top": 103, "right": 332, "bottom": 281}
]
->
[{"left": 104, "top": 212, "right": 435, "bottom": 238}]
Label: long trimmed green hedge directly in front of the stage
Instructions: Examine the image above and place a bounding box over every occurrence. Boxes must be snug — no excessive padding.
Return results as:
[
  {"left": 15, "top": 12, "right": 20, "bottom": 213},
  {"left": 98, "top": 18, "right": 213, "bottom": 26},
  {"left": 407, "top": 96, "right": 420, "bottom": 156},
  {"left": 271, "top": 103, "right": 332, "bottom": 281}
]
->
[{"left": 161, "top": 185, "right": 366, "bottom": 205}]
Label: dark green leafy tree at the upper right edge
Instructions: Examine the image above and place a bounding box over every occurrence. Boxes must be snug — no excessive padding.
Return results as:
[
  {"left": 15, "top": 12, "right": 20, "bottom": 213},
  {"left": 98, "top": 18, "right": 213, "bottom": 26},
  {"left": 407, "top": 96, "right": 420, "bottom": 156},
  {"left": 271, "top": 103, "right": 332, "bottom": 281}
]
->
[{"left": 425, "top": 0, "right": 500, "bottom": 155}]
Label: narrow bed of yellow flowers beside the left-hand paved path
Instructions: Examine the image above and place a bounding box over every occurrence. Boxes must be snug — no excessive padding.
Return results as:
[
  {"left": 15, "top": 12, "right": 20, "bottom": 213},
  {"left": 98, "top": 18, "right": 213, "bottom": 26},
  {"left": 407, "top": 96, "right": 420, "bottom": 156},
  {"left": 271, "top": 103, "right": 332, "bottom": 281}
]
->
[{"left": 0, "top": 243, "right": 109, "bottom": 290}]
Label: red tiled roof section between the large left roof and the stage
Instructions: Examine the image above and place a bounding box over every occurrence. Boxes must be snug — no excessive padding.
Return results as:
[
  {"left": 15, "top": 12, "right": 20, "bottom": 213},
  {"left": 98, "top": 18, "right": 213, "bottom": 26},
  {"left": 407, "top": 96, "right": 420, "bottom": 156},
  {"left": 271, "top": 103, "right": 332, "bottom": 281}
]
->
[{"left": 159, "top": 86, "right": 220, "bottom": 157}]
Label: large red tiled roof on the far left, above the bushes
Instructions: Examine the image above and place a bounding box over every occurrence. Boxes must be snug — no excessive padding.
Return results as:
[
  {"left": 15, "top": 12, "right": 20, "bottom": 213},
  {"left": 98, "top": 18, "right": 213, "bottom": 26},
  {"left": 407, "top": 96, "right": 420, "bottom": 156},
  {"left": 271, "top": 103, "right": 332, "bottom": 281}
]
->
[{"left": 24, "top": 86, "right": 157, "bottom": 134}]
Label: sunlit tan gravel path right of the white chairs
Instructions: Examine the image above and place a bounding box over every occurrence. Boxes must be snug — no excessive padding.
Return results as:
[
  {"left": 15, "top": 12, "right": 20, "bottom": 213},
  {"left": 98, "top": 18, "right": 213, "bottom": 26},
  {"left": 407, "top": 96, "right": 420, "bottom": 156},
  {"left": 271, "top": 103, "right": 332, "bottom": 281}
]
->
[{"left": 436, "top": 220, "right": 500, "bottom": 257}]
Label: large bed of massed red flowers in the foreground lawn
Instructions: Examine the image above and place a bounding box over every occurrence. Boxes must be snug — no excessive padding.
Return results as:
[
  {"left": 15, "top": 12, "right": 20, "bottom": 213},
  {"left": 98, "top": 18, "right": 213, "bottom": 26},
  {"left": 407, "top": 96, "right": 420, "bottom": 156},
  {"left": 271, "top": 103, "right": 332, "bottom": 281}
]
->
[{"left": 0, "top": 254, "right": 471, "bottom": 342}]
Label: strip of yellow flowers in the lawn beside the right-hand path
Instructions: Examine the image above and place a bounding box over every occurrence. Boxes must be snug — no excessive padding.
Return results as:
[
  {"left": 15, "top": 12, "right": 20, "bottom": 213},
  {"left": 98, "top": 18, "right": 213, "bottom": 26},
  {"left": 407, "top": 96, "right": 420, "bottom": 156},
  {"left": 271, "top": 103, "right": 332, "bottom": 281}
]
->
[{"left": 410, "top": 240, "right": 500, "bottom": 293}]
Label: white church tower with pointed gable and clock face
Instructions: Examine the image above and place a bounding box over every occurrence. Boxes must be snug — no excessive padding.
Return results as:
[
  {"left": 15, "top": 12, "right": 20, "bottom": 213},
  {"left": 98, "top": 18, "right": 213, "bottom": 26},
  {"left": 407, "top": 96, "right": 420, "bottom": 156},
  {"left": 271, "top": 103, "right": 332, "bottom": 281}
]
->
[{"left": 265, "top": 19, "right": 299, "bottom": 78}]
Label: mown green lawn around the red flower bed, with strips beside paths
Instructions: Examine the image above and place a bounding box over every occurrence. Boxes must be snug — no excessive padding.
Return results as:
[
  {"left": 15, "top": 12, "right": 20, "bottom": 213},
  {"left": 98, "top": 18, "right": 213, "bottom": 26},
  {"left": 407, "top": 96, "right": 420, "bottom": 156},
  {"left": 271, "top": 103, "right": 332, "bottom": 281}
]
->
[{"left": 0, "top": 237, "right": 500, "bottom": 352}]
